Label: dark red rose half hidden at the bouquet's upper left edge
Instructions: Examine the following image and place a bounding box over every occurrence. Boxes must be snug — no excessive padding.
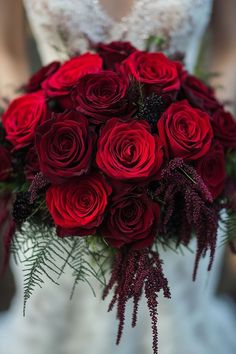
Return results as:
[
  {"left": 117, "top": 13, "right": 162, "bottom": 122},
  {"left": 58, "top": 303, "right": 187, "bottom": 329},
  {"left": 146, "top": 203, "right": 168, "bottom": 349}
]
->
[{"left": 25, "top": 61, "right": 61, "bottom": 92}]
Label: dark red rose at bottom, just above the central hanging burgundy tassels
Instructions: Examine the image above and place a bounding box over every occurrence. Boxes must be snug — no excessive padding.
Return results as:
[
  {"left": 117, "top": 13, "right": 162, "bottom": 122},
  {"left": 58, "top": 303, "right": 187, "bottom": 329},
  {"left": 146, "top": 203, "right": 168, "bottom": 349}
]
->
[{"left": 101, "top": 189, "right": 160, "bottom": 249}]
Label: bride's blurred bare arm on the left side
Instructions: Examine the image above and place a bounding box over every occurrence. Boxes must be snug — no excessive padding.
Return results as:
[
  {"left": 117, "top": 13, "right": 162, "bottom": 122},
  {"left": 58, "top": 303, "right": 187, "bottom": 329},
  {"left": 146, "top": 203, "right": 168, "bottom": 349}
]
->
[{"left": 0, "top": 0, "right": 29, "bottom": 104}]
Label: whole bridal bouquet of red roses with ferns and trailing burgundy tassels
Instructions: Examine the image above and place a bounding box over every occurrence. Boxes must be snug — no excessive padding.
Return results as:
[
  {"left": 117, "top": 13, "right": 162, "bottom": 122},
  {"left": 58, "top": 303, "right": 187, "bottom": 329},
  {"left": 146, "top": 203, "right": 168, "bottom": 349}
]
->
[{"left": 0, "top": 42, "right": 236, "bottom": 353}]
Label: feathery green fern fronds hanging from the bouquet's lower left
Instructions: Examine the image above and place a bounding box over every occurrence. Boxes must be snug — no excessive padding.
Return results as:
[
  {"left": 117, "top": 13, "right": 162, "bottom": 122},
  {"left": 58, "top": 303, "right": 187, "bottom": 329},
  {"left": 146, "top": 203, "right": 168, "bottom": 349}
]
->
[{"left": 12, "top": 222, "right": 112, "bottom": 314}]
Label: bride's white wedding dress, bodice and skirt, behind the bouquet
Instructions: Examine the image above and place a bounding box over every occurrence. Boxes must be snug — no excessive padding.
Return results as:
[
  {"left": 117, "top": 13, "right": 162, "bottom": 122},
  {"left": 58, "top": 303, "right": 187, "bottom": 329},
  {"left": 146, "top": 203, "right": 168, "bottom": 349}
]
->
[{"left": 0, "top": 0, "right": 236, "bottom": 354}]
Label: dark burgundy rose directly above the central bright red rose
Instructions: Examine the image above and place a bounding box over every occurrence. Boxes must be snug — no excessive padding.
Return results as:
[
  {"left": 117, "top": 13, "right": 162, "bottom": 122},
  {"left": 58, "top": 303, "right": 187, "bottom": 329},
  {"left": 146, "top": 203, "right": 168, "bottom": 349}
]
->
[{"left": 73, "top": 71, "right": 129, "bottom": 124}]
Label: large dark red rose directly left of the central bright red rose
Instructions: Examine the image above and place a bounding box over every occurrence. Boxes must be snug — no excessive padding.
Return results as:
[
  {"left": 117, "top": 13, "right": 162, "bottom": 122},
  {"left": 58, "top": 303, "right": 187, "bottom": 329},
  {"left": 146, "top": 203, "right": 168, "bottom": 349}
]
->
[{"left": 35, "top": 111, "right": 94, "bottom": 184}]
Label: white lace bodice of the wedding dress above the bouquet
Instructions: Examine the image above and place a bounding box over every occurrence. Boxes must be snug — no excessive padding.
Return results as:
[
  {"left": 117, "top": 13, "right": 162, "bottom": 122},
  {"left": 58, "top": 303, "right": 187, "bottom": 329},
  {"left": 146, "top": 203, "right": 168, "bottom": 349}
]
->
[{"left": 24, "top": 0, "right": 212, "bottom": 70}]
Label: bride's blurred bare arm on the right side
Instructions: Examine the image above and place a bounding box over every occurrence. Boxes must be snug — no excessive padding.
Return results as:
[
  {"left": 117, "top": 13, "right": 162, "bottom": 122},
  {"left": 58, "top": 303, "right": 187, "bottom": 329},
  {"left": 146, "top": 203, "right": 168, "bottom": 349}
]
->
[{"left": 210, "top": 0, "right": 236, "bottom": 111}]
